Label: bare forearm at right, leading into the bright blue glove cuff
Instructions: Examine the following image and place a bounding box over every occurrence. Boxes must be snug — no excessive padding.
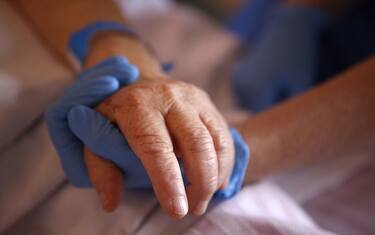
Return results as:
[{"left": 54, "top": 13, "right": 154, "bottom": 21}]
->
[{"left": 240, "top": 57, "right": 375, "bottom": 182}]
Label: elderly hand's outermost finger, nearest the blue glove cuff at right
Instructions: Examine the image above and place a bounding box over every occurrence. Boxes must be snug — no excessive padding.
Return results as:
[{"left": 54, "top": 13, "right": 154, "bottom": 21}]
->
[{"left": 199, "top": 112, "right": 234, "bottom": 190}]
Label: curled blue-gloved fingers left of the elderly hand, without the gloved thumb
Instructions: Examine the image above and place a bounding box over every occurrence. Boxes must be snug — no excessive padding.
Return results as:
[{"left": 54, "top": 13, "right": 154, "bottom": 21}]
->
[{"left": 45, "top": 57, "right": 139, "bottom": 187}]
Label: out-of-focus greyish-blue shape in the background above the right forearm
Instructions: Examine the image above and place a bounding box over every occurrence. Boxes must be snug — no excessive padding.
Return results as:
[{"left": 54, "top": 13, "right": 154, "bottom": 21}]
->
[{"left": 233, "top": 4, "right": 327, "bottom": 111}]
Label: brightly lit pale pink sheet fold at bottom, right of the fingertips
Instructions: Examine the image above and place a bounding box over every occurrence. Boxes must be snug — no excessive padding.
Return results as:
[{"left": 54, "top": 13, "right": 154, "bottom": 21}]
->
[{"left": 186, "top": 183, "right": 333, "bottom": 235}]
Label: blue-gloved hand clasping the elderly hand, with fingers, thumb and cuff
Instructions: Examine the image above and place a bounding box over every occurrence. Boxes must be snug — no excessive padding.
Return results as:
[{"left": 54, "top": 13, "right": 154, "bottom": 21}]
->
[{"left": 46, "top": 57, "right": 253, "bottom": 199}]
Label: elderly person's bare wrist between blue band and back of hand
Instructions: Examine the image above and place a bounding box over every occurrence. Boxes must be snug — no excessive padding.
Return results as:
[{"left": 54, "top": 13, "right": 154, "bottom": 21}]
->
[{"left": 84, "top": 31, "right": 166, "bottom": 80}]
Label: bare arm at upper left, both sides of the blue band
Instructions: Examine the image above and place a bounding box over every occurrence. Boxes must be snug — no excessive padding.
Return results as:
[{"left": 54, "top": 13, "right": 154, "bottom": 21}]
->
[{"left": 10, "top": 0, "right": 164, "bottom": 77}]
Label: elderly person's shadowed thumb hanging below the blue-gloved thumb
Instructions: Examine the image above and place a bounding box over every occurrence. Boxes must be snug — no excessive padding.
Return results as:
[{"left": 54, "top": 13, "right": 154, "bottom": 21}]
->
[{"left": 84, "top": 147, "right": 123, "bottom": 212}]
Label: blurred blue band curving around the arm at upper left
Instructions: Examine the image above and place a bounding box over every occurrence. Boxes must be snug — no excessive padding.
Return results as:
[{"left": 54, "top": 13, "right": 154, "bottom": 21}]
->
[{"left": 69, "top": 21, "right": 136, "bottom": 64}]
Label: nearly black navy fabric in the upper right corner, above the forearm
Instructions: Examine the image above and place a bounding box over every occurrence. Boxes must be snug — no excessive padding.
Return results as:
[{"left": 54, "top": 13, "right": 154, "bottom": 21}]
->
[{"left": 316, "top": 0, "right": 375, "bottom": 83}]
